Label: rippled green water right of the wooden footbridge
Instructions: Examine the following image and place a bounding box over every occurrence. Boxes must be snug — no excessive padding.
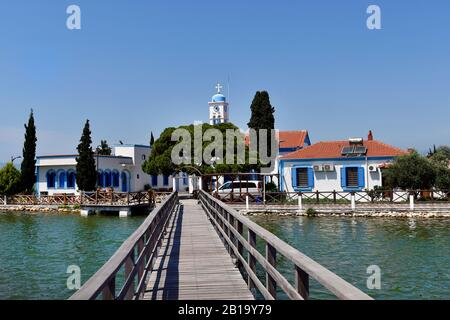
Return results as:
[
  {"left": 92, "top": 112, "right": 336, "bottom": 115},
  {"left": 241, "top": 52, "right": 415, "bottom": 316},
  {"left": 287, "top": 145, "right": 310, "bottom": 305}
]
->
[{"left": 251, "top": 216, "right": 450, "bottom": 299}]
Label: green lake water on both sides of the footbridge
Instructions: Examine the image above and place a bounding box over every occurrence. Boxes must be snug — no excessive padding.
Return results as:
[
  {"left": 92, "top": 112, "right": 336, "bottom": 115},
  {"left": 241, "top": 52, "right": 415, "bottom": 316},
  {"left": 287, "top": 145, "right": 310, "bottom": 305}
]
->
[{"left": 0, "top": 213, "right": 450, "bottom": 299}]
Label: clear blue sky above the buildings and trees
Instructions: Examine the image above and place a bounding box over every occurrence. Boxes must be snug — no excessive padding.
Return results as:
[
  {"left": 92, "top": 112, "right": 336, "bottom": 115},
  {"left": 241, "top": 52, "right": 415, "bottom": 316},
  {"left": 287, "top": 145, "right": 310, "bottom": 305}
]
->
[{"left": 0, "top": 0, "right": 450, "bottom": 162}]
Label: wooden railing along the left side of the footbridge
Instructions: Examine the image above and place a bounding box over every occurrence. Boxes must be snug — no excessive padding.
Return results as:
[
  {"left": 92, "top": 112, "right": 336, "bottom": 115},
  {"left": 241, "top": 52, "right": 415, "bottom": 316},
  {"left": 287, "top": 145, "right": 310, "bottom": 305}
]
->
[{"left": 70, "top": 192, "right": 178, "bottom": 300}]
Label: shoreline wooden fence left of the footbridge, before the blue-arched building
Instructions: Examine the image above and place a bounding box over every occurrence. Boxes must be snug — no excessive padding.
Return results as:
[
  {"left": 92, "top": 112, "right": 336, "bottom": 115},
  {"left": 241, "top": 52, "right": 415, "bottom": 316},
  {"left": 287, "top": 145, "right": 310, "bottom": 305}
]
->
[{"left": 0, "top": 191, "right": 170, "bottom": 206}]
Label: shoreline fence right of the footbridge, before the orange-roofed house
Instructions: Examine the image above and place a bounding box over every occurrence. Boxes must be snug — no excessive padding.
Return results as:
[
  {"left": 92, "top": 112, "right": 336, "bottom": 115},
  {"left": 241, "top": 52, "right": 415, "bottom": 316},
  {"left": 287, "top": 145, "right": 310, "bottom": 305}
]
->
[{"left": 211, "top": 189, "right": 450, "bottom": 204}]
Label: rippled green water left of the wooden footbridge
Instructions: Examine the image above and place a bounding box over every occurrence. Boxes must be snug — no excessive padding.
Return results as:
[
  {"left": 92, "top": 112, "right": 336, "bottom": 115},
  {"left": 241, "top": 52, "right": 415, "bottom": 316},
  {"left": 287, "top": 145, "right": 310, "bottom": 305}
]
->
[{"left": 0, "top": 213, "right": 144, "bottom": 299}]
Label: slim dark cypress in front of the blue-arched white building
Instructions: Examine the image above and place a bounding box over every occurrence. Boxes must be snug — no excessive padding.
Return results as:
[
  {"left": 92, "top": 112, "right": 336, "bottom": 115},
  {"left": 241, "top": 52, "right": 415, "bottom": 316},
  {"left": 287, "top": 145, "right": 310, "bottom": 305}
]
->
[{"left": 77, "top": 120, "right": 97, "bottom": 191}]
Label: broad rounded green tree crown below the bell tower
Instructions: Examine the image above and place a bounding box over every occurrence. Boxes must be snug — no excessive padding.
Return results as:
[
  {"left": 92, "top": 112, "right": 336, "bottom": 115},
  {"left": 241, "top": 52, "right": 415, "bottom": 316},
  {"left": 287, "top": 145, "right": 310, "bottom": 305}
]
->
[{"left": 142, "top": 123, "right": 259, "bottom": 175}]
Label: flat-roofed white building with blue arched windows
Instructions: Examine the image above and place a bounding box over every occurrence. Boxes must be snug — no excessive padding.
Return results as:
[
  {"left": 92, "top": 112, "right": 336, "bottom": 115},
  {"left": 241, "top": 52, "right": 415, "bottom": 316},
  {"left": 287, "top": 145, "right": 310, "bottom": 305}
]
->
[{"left": 36, "top": 145, "right": 189, "bottom": 195}]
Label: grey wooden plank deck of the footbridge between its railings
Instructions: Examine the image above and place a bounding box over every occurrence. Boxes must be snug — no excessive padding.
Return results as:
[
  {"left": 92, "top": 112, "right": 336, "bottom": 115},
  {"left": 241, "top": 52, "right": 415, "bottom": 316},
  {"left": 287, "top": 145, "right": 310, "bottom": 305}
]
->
[{"left": 144, "top": 199, "right": 254, "bottom": 300}]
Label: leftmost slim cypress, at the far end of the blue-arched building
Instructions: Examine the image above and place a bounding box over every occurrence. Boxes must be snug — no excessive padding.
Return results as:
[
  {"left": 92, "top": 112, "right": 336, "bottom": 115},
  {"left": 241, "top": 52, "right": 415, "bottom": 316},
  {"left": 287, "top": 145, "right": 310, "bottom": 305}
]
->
[{"left": 20, "top": 109, "right": 37, "bottom": 194}]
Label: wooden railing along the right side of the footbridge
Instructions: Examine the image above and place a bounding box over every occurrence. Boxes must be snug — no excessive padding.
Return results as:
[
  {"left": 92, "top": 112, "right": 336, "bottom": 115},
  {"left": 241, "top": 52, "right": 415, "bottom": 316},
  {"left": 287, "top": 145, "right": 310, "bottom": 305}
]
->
[{"left": 199, "top": 191, "right": 372, "bottom": 300}]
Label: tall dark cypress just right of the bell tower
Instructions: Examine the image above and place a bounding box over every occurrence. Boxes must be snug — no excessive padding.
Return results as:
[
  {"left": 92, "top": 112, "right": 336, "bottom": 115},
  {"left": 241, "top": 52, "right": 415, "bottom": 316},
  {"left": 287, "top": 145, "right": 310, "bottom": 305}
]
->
[{"left": 248, "top": 91, "right": 275, "bottom": 155}]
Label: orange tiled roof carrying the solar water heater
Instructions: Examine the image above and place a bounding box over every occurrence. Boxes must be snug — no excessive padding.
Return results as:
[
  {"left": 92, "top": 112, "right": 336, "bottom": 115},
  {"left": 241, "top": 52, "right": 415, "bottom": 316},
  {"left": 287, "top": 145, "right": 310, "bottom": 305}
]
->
[{"left": 282, "top": 140, "right": 407, "bottom": 159}]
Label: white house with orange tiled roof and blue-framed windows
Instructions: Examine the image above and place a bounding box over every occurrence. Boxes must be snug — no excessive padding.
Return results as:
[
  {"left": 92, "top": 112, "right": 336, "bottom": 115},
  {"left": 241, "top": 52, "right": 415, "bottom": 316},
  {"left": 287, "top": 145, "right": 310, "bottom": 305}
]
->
[{"left": 278, "top": 132, "right": 406, "bottom": 192}]
